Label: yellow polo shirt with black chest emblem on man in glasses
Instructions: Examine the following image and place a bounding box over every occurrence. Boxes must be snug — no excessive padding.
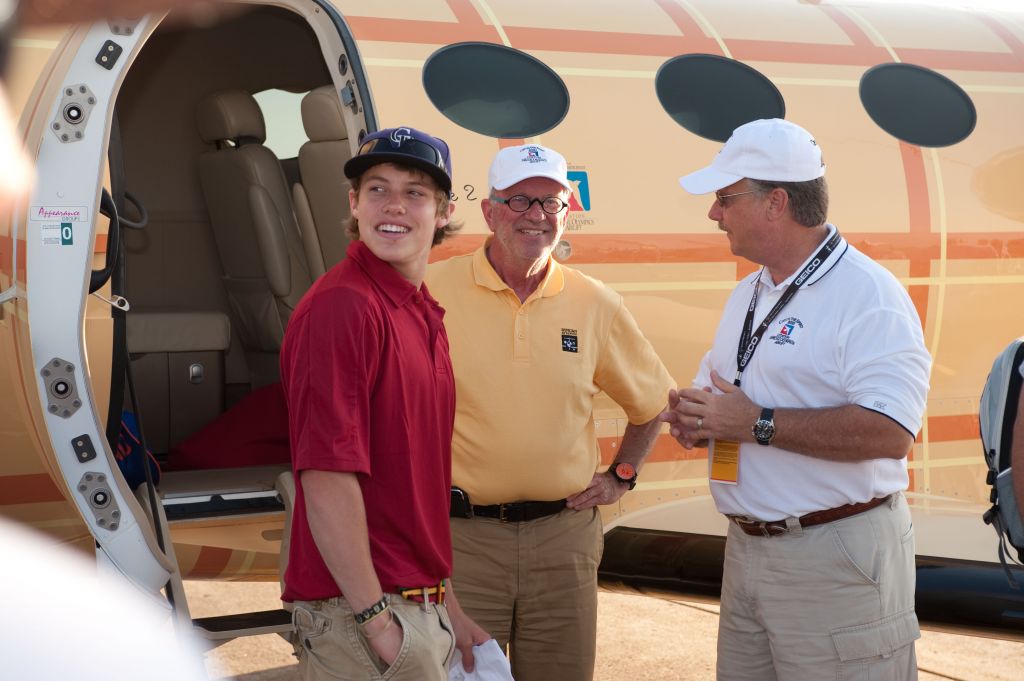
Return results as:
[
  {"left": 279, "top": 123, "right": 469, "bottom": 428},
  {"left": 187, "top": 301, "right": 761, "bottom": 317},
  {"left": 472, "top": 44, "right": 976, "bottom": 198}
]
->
[{"left": 426, "top": 245, "right": 675, "bottom": 504}]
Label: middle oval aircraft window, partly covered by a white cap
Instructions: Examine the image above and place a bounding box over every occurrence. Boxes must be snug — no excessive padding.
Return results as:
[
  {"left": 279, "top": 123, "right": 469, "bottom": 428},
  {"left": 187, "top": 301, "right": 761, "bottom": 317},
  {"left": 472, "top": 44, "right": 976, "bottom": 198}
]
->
[{"left": 654, "top": 54, "right": 785, "bottom": 142}]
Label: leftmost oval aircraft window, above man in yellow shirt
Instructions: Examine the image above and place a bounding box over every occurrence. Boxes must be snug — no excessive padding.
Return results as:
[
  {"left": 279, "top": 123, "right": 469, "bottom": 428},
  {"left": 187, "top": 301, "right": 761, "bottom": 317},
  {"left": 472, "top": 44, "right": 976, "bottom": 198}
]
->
[{"left": 423, "top": 42, "right": 569, "bottom": 138}]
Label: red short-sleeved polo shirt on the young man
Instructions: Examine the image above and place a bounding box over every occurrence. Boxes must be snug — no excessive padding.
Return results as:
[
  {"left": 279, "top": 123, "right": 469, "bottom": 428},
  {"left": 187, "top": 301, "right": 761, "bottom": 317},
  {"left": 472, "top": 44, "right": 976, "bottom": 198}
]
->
[{"left": 281, "top": 241, "right": 455, "bottom": 601}]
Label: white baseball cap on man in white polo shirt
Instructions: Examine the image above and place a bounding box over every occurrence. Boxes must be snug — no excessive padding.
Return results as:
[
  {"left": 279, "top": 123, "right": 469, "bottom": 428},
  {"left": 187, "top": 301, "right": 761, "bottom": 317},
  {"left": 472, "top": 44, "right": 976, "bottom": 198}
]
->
[{"left": 679, "top": 118, "right": 825, "bottom": 194}]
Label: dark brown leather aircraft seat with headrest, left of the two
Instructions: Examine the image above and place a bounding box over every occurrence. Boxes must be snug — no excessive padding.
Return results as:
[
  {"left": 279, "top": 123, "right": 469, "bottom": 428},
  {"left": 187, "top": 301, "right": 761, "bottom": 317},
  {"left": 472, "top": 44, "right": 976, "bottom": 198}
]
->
[{"left": 197, "top": 90, "right": 312, "bottom": 360}]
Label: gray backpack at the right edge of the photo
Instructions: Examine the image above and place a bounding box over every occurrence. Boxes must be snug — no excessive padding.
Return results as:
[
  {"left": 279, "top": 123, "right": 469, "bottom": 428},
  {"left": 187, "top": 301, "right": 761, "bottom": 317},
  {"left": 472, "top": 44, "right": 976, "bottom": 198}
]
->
[{"left": 978, "top": 337, "right": 1024, "bottom": 589}]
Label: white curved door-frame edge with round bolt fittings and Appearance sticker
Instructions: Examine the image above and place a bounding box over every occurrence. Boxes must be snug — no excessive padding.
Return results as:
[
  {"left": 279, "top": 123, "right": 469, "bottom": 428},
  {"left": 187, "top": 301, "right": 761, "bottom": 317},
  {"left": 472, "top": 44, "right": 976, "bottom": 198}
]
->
[{"left": 22, "top": 16, "right": 176, "bottom": 594}]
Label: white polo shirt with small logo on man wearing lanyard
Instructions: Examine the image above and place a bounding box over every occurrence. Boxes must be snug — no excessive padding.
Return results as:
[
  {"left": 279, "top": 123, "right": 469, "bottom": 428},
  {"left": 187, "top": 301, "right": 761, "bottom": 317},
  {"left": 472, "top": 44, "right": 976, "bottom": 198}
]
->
[{"left": 693, "top": 225, "right": 932, "bottom": 520}]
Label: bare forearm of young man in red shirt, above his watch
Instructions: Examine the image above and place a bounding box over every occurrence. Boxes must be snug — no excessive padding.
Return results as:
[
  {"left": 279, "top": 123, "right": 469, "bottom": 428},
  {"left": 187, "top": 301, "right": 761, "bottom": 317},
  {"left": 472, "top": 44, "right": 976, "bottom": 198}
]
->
[{"left": 301, "top": 470, "right": 382, "bottom": 612}]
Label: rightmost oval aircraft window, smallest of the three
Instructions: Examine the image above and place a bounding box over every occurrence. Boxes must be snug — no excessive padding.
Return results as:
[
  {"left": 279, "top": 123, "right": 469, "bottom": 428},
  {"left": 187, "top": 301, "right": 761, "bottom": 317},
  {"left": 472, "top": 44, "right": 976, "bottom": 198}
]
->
[{"left": 860, "top": 63, "right": 978, "bottom": 146}]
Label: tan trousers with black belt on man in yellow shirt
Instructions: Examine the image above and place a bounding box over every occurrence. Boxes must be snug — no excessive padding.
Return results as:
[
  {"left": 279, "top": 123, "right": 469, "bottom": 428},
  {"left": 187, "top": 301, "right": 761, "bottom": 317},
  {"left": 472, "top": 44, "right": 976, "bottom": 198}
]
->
[{"left": 452, "top": 509, "right": 604, "bottom": 681}]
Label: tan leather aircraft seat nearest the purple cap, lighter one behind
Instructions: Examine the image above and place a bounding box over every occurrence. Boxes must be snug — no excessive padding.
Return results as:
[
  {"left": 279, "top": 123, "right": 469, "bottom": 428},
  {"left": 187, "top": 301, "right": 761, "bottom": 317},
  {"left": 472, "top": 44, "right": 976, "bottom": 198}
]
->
[{"left": 292, "top": 85, "right": 352, "bottom": 272}]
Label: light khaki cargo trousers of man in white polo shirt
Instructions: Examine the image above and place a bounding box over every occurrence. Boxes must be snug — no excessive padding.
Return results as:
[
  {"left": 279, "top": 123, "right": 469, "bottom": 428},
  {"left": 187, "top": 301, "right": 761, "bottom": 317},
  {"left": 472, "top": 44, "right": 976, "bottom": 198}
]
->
[{"left": 718, "top": 494, "right": 921, "bottom": 681}]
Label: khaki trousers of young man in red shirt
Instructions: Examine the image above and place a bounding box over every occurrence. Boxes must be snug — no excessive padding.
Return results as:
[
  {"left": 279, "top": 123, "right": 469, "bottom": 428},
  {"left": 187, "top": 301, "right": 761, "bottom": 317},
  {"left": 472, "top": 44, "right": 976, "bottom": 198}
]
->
[{"left": 292, "top": 594, "right": 455, "bottom": 681}]
